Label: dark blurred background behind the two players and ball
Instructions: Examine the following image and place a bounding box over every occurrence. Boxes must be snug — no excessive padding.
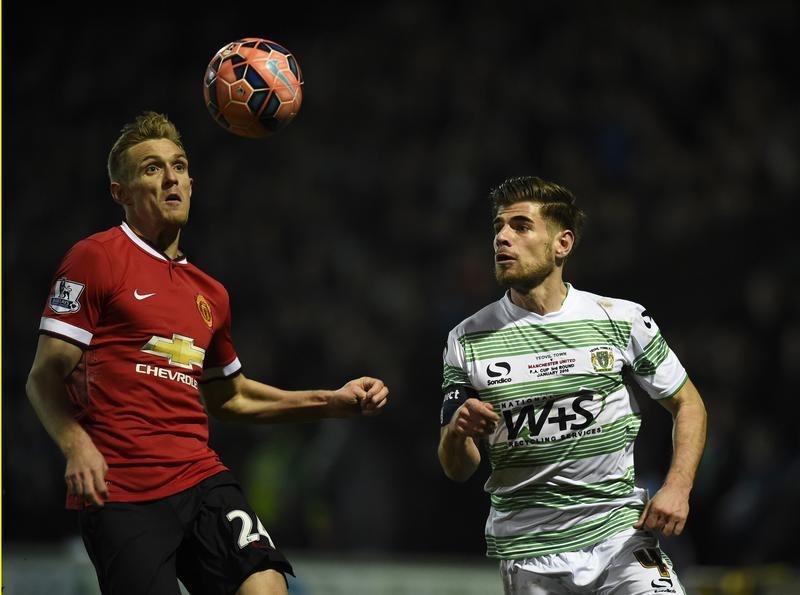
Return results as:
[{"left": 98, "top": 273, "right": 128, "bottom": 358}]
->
[{"left": 2, "top": 0, "right": 800, "bottom": 565}]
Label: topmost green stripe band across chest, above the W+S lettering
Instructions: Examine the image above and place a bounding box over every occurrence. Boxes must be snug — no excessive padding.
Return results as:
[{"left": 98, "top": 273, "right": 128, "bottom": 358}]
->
[{"left": 459, "top": 319, "right": 632, "bottom": 362}]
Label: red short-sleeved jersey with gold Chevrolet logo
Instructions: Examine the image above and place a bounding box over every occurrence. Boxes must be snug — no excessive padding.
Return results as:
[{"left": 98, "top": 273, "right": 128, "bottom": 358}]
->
[{"left": 39, "top": 223, "right": 241, "bottom": 508}]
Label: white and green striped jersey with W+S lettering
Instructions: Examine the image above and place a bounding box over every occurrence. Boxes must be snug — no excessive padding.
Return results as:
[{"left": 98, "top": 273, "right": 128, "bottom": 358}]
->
[{"left": 442, "top": 285, "right": 687, "bottom": 559}]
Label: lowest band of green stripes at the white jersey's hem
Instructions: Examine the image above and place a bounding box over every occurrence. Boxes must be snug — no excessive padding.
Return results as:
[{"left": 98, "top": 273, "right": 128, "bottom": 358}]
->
[{"left": 486, "top": 506, "right": 641, "bottom": 560}]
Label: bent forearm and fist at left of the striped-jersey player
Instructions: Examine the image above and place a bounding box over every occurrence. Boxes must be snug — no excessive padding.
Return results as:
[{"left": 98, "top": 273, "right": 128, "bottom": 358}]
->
[{"left": 438, "top": 398, "right": 500, "bottom": 481}]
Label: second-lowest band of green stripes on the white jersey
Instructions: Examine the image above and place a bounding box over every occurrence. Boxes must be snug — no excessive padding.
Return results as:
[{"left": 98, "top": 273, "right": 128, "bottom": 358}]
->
[{"left": 491, "top": 466, "right": 635, "bottom": 512}]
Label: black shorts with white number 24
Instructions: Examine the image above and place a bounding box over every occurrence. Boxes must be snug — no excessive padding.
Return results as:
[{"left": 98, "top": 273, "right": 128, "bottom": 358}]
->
[{"left": 79, "top": 471, "right": 294, "bottom": 595}]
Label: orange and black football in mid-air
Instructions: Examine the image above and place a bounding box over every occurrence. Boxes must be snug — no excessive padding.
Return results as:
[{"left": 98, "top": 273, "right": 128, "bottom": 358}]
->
[{"left": 203, "top": 37, "right": 303, "bottom": 138}]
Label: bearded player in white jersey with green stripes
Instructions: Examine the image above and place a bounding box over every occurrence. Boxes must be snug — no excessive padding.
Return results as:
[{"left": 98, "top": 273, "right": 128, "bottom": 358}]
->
[{"left": 439, "top": 177, "right": 706, "bottom": 595}]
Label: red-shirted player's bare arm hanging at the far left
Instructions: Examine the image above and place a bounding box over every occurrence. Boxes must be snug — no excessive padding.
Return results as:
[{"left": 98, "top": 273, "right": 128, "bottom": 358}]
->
[{"left": 25, "top": 335, "right": 108, "bottom": 505}]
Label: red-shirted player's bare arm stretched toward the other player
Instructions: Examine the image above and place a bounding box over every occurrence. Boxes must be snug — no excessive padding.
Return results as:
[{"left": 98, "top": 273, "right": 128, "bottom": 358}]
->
[{"left": 200, "top": 374, "right": 389, "bottom": 423}]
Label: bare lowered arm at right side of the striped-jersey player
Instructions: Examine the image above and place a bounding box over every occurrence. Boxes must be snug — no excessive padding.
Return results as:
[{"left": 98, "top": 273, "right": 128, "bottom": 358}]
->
[{"left": 634, "top": 380, "right": 707, "bottom": 536}]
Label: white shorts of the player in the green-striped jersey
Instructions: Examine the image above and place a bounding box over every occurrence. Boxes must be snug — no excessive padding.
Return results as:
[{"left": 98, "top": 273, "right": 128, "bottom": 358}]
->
[{"left": 500, "top": 529, "right": 686, "bottom": 595}]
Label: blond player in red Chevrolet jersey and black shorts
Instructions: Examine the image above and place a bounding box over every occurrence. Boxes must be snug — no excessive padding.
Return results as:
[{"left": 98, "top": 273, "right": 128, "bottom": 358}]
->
[{"left": 26, "top": 112, "right": 389, "bottom": 595}]
